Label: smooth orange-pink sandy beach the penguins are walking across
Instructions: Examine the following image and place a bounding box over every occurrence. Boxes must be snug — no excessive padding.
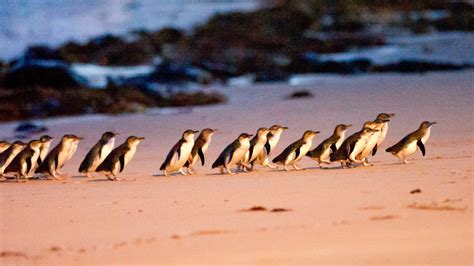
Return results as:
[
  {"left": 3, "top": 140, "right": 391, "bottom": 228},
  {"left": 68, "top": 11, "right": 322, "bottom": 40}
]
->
[{"left": 0, "top": 71, "right": 474, "bottom": 265}]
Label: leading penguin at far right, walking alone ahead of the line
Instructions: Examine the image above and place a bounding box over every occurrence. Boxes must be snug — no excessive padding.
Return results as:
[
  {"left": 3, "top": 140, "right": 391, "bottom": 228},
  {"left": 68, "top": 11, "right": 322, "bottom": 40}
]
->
[{"left": 385, "top": 121, "right": 436, "bottom": 164}]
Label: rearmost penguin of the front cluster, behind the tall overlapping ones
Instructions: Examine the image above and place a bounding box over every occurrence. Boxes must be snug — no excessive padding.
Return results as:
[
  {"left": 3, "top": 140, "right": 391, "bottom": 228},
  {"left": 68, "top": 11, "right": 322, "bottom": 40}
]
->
[{"left": 306, "top": 124, "right": 352, "bottom": 168}]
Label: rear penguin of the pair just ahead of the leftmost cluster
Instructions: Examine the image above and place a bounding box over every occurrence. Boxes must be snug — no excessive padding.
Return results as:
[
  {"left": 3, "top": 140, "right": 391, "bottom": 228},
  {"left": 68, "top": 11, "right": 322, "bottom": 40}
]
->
[{"left": 79, "top": 131, "right": 119, "bottom": 177}]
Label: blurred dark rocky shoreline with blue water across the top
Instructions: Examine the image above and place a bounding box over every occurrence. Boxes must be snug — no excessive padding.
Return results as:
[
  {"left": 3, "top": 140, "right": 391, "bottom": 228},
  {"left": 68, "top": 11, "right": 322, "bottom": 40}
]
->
[{"left": 0, "top": 0, "right": 474, "bottom": 121}]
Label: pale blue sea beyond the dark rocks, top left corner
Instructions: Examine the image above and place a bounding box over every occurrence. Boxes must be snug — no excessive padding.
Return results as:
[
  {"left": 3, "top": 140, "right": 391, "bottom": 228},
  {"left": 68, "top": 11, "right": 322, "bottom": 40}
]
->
[{"left": 0, "top": 0, "right": 260, "bottom": 59}]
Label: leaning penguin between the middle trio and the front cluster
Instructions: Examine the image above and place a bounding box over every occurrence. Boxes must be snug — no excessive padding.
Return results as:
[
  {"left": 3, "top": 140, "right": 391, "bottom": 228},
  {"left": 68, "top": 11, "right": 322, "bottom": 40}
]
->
[{"left": 273, "top": 130, "right": 319, "bottom": 171}]
